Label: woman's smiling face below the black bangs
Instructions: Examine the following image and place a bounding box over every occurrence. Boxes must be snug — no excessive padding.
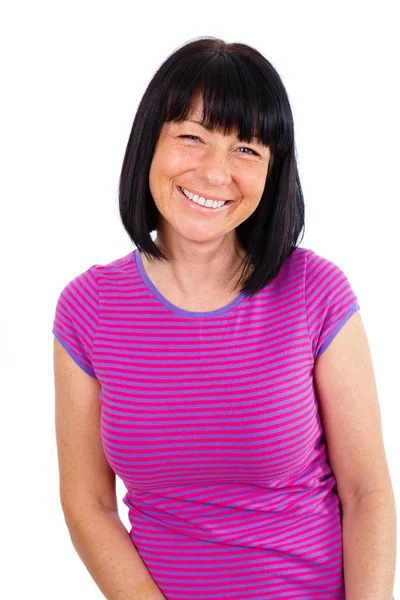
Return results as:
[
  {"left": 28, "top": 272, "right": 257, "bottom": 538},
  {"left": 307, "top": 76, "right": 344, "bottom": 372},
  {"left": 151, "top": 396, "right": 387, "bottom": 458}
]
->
[{"left": 149, "top": 97, "right": 270, "bottom": 247}]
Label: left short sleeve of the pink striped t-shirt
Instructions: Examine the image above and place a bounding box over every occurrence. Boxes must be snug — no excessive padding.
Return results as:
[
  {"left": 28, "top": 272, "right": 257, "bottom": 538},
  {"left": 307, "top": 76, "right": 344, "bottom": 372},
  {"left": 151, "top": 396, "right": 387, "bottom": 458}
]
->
[{"left": 52, "top": 267, "right": 98, "bottom": 378}]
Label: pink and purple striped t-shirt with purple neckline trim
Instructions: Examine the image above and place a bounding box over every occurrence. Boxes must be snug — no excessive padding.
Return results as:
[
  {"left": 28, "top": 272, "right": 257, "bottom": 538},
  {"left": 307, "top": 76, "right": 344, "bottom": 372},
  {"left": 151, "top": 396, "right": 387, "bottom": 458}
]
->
[{"left": 53, "top": 247, "right": 360, "bottom": 600}]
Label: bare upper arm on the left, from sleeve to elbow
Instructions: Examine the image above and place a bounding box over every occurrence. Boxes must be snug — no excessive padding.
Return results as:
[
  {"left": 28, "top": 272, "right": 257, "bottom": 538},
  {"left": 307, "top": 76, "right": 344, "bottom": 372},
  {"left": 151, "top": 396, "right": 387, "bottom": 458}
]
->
[{"left": 53, "top": 337, "right": 117, "bottom": 517}]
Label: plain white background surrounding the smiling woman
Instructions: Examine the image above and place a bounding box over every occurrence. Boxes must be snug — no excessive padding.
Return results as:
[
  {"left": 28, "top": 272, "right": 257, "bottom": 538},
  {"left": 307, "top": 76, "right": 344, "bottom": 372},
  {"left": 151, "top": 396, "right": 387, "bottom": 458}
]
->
[{"left": 0, "top": 0, "right": 400, "bottom": 600}]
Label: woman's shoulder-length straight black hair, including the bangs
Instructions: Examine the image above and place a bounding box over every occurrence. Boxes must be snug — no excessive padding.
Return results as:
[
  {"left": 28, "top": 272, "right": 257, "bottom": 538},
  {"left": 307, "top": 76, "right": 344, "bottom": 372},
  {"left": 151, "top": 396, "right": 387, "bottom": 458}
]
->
[{"left": 119, "top": 37, "right": 304, "bottom": 296}]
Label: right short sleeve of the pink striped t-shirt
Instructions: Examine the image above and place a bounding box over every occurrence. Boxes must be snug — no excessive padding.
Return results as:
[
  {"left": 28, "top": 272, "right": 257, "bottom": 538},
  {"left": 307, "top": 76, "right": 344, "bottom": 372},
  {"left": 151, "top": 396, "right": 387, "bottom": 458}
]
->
[{"left": 305, "top": 250, "right": 360, "bottom": 360}]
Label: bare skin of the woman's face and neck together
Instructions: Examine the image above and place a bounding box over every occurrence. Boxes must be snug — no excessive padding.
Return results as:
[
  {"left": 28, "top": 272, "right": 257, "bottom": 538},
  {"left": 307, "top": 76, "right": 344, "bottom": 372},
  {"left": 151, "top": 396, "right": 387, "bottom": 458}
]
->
[{"left": 142, "top": 96, "right": 271, "bottom": 298}]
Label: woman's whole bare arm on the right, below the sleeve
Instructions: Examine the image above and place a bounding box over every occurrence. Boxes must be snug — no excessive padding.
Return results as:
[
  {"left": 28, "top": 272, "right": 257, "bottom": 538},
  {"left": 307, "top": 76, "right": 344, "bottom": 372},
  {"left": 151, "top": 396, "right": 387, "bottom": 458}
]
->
[{"left": 314, "top": 312, "right": 397, "bottom": 600}]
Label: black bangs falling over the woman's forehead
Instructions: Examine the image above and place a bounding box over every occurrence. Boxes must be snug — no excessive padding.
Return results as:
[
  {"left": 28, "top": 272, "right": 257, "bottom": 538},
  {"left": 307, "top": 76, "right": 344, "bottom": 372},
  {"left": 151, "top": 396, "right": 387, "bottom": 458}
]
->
[{"left": 163, "top": 53, "right": 282, "bottom": 146}]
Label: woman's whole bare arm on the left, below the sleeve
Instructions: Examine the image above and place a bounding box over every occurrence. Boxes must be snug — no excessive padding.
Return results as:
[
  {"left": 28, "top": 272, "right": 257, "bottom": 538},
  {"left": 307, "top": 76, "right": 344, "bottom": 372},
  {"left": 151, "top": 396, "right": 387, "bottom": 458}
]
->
[{"left": 54, "top": 337, "right": 166, "bottom": 600}]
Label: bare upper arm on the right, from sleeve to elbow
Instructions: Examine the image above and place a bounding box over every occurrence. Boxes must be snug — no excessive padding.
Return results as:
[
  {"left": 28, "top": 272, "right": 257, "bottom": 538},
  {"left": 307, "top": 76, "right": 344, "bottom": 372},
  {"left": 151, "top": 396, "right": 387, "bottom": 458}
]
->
[{"left": 314, "top": 312, "right": 391, "bottom": 504}]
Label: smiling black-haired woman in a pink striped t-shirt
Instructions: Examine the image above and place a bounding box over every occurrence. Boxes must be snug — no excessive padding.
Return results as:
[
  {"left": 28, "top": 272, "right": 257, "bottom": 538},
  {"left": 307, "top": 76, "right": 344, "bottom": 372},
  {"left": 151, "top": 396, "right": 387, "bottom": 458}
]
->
[{"left": 53, "top": 38, "right": 396, "bottom": 600}]
